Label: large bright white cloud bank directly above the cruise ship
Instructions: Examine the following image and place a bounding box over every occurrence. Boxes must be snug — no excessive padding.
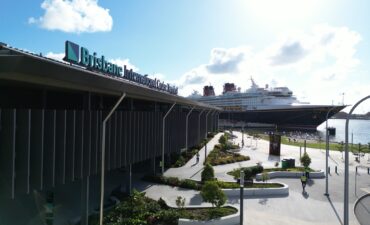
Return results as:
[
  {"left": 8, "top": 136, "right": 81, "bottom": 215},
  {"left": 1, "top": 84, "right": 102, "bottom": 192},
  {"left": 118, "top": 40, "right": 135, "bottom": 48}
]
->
[{"left": 176, "top": 25, "right": 364, "bottom": 111}]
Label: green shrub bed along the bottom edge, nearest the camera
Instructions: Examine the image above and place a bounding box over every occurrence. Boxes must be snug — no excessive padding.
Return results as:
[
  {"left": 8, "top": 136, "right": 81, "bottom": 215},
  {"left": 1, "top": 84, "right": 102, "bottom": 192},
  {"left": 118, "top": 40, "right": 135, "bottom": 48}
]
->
[{"left": 86, "top": 190, "right": 237, "bottom": 225}]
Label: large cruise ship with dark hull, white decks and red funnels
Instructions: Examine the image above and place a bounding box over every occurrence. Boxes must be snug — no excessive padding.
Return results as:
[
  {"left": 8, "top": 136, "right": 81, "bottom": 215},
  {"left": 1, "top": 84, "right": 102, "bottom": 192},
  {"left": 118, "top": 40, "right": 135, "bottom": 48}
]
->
[{"left": 189, "top": 79, "right": 346, "bottom": 130}]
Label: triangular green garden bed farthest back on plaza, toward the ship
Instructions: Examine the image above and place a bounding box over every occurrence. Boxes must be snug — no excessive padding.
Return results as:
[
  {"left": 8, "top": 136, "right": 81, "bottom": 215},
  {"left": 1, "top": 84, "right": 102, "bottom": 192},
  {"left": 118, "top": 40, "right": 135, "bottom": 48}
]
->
[{"left": 205, "top": 133, "right": 250, "bottom": 166}]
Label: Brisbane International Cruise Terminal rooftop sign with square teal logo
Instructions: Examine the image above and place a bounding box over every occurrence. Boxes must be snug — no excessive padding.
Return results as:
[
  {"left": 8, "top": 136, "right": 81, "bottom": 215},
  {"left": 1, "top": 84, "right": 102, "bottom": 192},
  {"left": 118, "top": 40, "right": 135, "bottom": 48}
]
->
[{"left": 63, "top": 41, "right": 178, "bottom": 94}]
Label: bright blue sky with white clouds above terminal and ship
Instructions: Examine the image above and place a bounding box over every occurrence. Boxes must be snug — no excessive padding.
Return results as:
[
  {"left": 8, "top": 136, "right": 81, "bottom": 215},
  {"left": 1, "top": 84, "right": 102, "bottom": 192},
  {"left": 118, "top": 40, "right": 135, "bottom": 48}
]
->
[{"left": 0, "top": 0, "right": 370, "bottom": 113}]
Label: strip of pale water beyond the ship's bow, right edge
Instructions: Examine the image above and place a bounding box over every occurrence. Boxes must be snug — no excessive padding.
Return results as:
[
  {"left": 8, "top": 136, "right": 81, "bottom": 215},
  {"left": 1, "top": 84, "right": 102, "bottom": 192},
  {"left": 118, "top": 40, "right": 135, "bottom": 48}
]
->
[{"left": 317, "top": 119, "right": 370, "bottom": 144}]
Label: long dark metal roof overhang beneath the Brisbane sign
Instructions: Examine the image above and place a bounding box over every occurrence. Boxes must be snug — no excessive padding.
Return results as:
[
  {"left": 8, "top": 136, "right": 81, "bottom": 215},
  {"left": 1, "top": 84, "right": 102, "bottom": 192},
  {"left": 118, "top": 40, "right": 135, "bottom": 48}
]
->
[{"left": 0, "top": 46, "right": 221, "bottom": 111}]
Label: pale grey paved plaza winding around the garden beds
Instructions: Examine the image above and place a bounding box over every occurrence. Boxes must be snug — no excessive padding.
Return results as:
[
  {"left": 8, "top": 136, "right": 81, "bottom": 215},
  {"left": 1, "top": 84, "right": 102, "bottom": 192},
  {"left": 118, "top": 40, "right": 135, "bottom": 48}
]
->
[{"left": 135, "top": 132, "right": 370, "bottom": 225}]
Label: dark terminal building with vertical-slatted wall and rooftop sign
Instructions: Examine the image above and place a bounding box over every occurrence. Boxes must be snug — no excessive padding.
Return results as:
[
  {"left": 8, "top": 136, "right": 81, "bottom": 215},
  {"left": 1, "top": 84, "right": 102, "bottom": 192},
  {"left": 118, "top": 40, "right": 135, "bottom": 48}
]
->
[{"left": 0, "top": 42, "right": 220, "bottom": 225}]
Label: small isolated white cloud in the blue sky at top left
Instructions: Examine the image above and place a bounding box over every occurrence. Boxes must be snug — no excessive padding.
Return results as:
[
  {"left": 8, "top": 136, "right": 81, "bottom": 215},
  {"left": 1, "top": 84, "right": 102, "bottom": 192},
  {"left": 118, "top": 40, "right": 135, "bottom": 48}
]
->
[{"left": 28, "top": 0, "right": 113, "bottom": 33}]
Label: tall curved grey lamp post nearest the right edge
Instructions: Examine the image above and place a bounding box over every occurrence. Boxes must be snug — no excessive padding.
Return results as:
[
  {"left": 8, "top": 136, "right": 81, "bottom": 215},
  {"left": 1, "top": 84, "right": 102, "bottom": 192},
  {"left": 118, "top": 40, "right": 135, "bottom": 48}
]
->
[{"left": 343, "top": 95, "right": 370, "bottom": 225}]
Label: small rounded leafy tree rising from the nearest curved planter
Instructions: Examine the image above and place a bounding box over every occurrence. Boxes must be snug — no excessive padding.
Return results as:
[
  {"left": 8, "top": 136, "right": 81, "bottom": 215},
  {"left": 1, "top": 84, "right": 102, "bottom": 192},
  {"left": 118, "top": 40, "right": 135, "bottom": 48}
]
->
[{"left": 200, "top": 181, "right": 226, "bottom": 207}]
